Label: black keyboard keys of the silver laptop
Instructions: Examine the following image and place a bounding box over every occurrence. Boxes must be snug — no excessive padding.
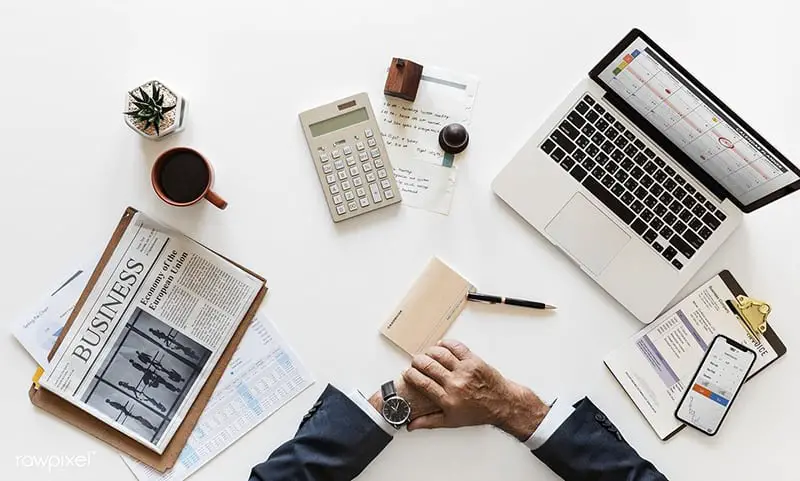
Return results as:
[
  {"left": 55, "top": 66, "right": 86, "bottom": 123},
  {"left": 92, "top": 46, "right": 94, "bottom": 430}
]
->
[{"left": 539, "top": 94, "right": 725, "bottom": 270}]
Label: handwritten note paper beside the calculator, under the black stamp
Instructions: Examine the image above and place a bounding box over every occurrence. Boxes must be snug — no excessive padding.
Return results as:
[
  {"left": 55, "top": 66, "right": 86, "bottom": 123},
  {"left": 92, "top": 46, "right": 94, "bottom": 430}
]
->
[{"left": 377, "top": 66, "right": 478, "bottom": 215}]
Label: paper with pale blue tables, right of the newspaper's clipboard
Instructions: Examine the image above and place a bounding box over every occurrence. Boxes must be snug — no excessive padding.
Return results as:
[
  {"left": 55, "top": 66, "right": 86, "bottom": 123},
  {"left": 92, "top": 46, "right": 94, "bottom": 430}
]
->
[{"left": 121, "top": 312, "right": 314, "bottom": 481}]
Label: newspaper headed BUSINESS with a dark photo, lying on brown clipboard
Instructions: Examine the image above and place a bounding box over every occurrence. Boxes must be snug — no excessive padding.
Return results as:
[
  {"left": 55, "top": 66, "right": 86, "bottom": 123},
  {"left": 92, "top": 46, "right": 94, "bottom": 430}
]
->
[{"left": 39, "top": 213, "right": 263, "bottom": 454}]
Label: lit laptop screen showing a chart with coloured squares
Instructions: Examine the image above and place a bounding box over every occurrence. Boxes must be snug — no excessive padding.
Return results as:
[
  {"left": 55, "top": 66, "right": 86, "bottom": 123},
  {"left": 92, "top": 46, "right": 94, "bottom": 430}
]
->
[{"left": 599, "top": 38, "right": 800, "bottom": 205}]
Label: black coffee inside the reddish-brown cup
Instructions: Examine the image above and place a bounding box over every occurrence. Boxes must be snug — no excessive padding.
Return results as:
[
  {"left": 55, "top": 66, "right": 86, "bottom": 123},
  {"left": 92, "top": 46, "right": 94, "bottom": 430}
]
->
[{"left": 158, "top": 150, "right": 210, "bottom": 204}]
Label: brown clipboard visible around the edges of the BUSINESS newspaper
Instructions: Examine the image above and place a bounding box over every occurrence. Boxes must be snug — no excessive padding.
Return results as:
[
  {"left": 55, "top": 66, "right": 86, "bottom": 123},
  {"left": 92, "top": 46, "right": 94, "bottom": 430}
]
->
[{"left": 28, "top": 207, "right": 267, "bottom": 473}]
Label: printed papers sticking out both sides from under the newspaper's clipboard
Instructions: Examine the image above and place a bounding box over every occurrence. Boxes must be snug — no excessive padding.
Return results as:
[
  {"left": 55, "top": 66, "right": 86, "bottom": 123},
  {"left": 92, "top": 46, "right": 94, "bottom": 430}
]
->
[{"left": 11, "top": 262, "right": 314, "bottom": 481}]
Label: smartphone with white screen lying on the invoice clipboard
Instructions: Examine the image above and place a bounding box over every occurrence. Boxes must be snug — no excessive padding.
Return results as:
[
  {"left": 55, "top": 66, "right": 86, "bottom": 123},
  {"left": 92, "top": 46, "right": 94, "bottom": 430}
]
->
[{"left": 675, "top": 334, "right": 756, "bottom": 436}]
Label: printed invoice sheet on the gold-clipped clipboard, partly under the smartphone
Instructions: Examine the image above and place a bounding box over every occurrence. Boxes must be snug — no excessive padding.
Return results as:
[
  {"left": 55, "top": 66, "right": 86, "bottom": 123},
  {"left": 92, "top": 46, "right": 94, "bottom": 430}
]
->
[{"left": 604, "top": 271, "right": 786, "bottom": 439}]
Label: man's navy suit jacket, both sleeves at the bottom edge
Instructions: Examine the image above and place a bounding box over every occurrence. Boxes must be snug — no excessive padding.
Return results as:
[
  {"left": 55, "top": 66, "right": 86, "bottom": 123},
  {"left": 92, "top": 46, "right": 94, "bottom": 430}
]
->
[{"left": 250, "top": 385, "right": 667, "bottom": 481}]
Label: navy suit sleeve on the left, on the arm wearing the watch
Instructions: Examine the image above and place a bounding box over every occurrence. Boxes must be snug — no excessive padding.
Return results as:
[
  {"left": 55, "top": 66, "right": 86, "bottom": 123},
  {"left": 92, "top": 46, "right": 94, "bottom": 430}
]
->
[{"left": 250, "top": 385, "right": 392, "bottom": 481}]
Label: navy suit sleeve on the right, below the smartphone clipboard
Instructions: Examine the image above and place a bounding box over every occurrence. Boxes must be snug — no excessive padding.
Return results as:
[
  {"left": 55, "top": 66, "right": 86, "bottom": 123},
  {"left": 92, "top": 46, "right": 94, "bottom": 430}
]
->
[{"left": 533, "top": 398, "right": 667, "bottom": 481}]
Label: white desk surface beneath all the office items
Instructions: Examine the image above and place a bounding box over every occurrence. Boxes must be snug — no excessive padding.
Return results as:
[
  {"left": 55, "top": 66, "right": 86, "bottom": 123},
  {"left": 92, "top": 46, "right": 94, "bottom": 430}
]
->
[{"left": 0, "top": 0, "right": 800, "bottom": 481}]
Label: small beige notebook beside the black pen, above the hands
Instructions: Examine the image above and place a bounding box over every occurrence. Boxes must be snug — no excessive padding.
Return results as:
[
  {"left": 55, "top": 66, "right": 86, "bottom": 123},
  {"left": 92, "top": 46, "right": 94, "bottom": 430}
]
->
[{"left": 381, "top": 257, "right": 475, "bottom": 356}]
